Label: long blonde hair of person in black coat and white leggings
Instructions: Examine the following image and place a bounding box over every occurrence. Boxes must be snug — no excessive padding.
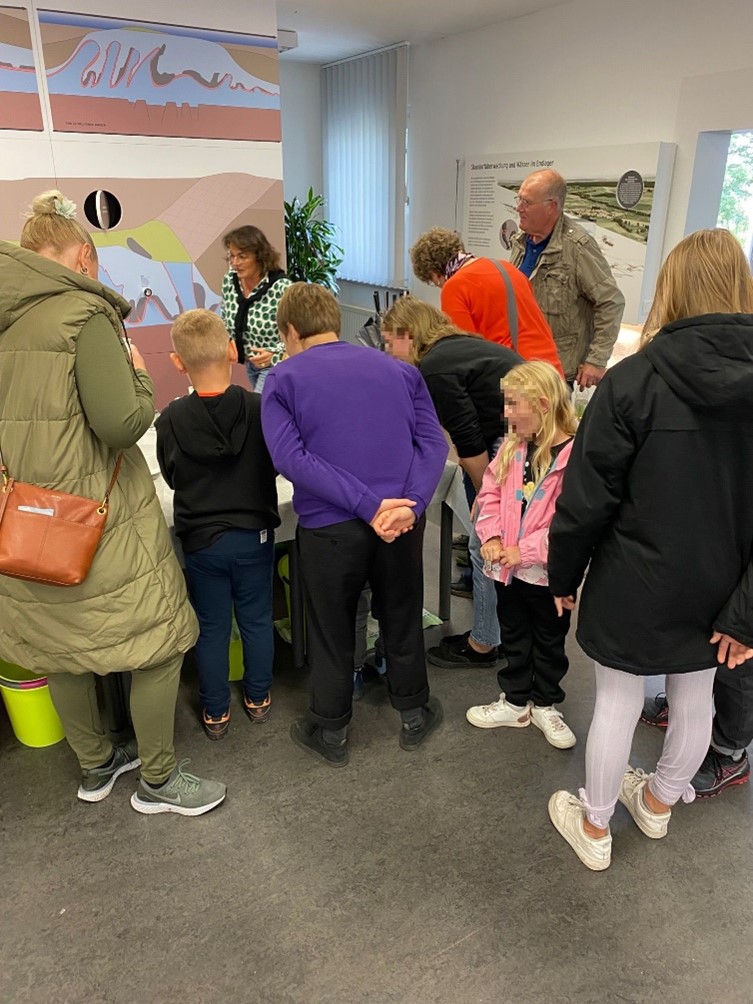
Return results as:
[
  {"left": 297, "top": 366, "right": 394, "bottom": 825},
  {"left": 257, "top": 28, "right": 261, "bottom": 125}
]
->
[{"left": 641, "top": 229, "right": 753, "bottom": 348}]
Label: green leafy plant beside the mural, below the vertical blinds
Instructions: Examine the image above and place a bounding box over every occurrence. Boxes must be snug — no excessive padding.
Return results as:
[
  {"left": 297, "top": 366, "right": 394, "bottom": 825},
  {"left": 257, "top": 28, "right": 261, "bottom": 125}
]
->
[{"left": 285, "top": 188, "right": 342, "bottom": 294}]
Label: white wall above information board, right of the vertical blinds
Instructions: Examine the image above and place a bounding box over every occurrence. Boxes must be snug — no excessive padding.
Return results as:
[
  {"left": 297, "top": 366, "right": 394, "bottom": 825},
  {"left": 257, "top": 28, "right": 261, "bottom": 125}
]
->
[{"left": 410, "top": 0, "right": 753, "bottom": 267}]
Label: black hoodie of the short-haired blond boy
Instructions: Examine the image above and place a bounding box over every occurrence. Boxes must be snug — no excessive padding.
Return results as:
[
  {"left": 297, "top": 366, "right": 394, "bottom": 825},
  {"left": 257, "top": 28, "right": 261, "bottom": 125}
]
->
[{"left": 156, "top": 386, "right": 280, "bottom": 553}]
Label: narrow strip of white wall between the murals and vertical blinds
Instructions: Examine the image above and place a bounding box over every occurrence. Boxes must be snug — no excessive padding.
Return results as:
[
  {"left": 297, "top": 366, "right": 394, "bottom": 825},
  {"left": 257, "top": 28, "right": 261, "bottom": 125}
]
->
[{"left": 279, "top": 57, "right": 323, "bottom": 202}]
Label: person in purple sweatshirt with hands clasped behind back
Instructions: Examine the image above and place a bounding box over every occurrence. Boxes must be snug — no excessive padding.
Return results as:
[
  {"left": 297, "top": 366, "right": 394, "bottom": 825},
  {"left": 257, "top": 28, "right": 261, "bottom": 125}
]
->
[{"left": 261, "top": 282, "right": 448, "bottom": 767}]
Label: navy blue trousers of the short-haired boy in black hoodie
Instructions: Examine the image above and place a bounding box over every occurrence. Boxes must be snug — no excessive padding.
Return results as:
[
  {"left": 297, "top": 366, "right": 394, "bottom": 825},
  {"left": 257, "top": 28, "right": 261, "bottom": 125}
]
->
[{"left": 186, "top": 530, "right": 274, "bottom": 718}]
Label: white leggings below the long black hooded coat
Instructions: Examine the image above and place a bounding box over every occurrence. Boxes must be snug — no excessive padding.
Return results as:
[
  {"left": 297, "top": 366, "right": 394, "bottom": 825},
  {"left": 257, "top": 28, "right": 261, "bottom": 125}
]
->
[{"left": 580, "top": 663, "right": 716, "bottom": 827}]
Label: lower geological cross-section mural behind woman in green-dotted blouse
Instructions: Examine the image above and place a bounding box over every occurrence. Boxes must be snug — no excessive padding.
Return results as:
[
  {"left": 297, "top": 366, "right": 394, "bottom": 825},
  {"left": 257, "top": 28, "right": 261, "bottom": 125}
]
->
[{"left": 0, "top": 174, "right": 285, "bottom": 408}]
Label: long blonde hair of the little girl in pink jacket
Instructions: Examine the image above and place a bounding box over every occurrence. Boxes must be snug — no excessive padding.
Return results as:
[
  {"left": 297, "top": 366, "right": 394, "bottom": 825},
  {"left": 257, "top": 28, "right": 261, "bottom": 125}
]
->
[{"left": 495, "top": 359, "right": 577, "bottom": 485}]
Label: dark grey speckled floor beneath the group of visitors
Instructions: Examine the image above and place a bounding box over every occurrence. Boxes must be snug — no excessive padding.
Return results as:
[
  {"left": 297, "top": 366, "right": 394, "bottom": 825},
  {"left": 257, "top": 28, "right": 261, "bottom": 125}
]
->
[{"left": 0, "top": 529, "right": 753, "bottom": 1004}]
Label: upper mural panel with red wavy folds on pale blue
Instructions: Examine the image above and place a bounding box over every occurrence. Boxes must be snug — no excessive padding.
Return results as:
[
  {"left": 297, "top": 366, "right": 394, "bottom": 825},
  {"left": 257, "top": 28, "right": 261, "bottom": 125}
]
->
[{"left": 36, "top": 8, "right": 281, "bottom": 142}]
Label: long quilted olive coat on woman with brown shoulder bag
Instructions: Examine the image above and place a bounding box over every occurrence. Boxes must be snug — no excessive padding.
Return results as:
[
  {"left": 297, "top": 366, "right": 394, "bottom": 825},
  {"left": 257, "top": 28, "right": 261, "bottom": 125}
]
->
[{"left": 0, "top": 241, "right": 198, "bottom": 674}]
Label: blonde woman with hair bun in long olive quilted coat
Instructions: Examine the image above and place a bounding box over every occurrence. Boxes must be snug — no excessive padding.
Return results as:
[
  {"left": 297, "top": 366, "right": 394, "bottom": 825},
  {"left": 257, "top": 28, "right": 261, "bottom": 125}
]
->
[{"left": 0, "top": 192, "right": 224, "bottom": 814}]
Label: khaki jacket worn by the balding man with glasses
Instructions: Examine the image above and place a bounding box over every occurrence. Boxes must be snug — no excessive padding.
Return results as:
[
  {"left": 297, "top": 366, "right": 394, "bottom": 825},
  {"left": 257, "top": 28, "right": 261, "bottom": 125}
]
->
[{"left": 510, "top": 214, "right": 624, "bottom": 381}]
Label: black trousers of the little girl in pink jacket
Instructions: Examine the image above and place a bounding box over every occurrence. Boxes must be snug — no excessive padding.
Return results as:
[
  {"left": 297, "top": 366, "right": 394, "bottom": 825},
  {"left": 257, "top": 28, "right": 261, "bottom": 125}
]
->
[{"left": 496, "top": 578, "right": 570, "bottom": 707}]
